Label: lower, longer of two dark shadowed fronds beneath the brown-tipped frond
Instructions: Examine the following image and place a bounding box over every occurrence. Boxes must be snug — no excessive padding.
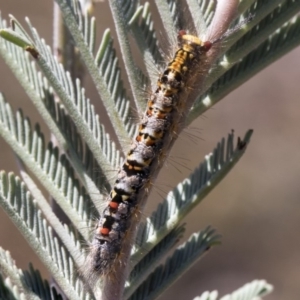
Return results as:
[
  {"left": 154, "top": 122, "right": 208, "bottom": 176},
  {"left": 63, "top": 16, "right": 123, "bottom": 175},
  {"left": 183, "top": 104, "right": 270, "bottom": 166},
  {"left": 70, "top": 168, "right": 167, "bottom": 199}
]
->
[{"left": 128, "top": 227, "right": 220, "bottom": 300}]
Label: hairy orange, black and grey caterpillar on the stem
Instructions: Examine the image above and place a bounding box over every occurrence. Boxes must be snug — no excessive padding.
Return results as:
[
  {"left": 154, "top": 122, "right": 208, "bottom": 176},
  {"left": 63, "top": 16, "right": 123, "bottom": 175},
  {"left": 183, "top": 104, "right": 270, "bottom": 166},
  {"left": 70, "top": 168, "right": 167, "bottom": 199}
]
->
[{"left": 88, "top": 30, "right": 213, "bottom": 279}]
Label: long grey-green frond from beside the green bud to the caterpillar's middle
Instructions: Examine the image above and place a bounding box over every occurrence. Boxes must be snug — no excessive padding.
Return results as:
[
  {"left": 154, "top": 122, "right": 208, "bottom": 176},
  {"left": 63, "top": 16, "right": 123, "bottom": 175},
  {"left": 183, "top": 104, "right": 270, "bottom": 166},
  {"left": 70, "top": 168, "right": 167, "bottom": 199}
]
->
[{"left": 22, "top": 20, "right": 126, "bottom": 173}]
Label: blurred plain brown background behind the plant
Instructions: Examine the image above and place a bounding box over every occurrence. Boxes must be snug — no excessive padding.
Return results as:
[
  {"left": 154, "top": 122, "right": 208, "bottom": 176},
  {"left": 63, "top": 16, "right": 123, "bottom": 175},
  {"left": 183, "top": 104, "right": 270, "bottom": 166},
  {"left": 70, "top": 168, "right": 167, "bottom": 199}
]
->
[{"left": 0, "top": 0, "right": 300, "bottom": 300}]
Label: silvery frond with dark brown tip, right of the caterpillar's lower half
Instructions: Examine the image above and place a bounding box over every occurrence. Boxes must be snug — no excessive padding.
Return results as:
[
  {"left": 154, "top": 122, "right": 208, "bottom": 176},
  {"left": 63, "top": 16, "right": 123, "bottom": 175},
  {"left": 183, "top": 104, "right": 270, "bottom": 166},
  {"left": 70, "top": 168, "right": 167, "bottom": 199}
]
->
[{"left": 132, "top": 130, "right": 252, "bottom": 263}]
